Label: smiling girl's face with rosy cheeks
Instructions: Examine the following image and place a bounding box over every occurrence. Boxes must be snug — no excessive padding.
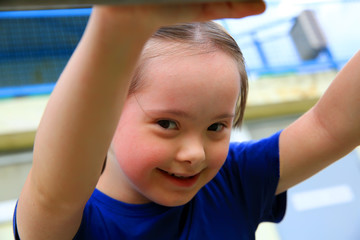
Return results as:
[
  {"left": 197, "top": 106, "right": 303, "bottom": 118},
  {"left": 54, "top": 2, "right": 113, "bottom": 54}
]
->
[{"left": 113, "top": 48, "right": 240, "bottom": 206}]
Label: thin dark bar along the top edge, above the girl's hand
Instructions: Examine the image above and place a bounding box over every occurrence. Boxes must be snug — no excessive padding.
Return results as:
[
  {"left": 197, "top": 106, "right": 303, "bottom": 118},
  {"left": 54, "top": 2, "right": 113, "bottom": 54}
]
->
[{"left": 0, "top": 0, "right": 260, "bottom": 11}]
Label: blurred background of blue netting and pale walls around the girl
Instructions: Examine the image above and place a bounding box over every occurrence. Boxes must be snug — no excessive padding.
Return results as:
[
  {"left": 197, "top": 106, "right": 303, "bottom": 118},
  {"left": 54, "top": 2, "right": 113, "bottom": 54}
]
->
[{"left": 0, "top": 0, "right": 360, "bottom": 240}]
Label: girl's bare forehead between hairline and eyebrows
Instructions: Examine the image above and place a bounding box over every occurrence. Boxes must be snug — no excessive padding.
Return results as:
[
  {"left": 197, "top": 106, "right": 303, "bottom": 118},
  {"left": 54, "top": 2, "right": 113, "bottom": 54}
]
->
[{"left": 137, "top": 51, "right": 240, "bottom": 101}]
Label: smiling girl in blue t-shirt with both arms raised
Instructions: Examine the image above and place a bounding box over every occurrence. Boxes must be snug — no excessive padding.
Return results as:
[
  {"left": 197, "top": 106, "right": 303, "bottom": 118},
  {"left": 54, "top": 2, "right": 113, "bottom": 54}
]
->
[{"left": 14, "top": 3, "right": 360, "bottom": 239}]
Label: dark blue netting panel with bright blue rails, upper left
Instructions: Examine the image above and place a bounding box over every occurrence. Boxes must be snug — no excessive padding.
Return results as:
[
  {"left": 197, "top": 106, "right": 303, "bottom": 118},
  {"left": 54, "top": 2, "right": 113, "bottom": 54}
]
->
[{"left": 0, "top": 9, "right": 90, "bottom": 97}]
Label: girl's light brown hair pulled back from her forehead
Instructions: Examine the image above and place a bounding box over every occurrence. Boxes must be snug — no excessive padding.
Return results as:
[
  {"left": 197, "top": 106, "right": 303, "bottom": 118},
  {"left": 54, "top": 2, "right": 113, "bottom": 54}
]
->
[{"left": 129, "top": 21, "right": 248, "bottom": 127}]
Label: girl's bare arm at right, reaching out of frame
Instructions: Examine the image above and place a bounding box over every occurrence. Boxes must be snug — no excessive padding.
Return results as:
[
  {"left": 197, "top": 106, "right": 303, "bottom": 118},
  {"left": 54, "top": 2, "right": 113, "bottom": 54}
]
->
[{"left": 277, "top": 52, "right": 360, "bottom": 193}]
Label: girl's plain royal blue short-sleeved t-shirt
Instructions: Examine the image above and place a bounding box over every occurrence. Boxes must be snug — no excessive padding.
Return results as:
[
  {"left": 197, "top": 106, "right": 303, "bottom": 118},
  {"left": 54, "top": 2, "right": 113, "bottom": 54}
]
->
[{"left": 14, "top": 133, "right": 286, "bottom": 240}]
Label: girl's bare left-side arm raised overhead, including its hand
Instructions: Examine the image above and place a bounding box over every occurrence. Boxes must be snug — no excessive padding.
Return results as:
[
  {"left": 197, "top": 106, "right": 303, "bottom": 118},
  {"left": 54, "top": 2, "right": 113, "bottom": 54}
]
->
[{"left": 17, "top": 3, "right": 264, "bottom": 240}]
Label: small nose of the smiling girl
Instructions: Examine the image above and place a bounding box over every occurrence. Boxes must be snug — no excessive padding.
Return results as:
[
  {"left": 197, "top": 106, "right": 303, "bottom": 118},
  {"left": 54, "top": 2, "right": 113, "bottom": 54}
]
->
[{"left": 176, "top": 138, "right": 206, "bottom": 165}]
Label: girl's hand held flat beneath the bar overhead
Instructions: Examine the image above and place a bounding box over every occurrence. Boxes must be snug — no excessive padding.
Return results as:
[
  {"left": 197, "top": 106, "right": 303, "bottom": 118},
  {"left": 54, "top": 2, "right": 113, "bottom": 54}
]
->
[{"left": 93, "top": 0, "right": 265, "bottom": 31}]
